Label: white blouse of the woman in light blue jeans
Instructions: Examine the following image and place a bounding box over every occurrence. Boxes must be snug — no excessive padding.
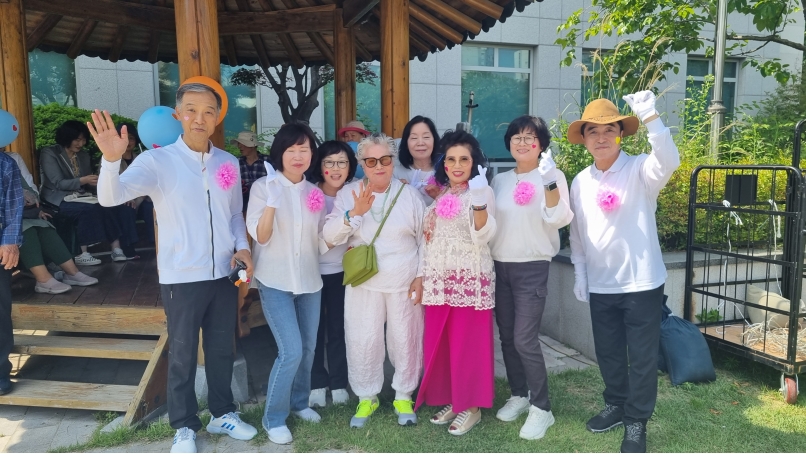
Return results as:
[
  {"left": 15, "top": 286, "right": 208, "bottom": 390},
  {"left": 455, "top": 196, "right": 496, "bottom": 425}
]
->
[{"left": 246, "top": 172, "right": 326, "bottom": 294}]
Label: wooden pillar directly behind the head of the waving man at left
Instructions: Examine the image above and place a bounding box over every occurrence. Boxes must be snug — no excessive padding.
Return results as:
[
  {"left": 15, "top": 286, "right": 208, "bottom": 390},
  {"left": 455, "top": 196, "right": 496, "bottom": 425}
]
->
[{"left": 174, "top": 0, "right": 224, "bottom": 148}]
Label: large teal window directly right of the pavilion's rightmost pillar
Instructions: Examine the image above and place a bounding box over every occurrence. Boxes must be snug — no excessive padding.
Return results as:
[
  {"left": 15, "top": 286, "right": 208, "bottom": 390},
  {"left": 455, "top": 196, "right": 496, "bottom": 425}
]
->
[{"left": 461, "top": 44, "right": 532, "bottom": 160}]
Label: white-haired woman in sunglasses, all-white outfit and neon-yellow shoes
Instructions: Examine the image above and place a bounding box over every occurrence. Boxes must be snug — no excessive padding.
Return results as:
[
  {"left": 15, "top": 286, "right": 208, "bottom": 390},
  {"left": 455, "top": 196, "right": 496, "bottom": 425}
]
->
[{"left": 322, "top": 134, "right": 425, "bottom": 427}]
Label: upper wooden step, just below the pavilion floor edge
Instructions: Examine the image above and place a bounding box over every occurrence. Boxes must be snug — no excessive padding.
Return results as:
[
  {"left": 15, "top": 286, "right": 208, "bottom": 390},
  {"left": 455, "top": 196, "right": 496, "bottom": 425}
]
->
[{"left": 12, "top": 334, "right": 157, "bottom": 361}]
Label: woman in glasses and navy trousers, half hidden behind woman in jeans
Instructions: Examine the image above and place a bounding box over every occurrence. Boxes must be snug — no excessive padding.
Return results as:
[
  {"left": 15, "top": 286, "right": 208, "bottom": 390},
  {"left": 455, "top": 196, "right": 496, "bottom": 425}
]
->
[{"left": 308, "top": 140, "right": 358, "bottom": 408}]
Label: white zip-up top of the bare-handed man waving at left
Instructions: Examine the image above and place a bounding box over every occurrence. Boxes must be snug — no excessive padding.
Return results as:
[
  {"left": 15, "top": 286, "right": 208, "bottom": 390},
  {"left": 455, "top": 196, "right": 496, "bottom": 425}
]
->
[{"left": 98, "top": 136, "right": 249, "bottom": 284}]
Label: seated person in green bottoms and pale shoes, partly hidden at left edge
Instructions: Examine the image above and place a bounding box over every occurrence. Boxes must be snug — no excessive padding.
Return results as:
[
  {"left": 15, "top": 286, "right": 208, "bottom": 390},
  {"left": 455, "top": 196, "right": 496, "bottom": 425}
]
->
[{"left": 20, "top": 179, "right": 98, "bottom": 294}]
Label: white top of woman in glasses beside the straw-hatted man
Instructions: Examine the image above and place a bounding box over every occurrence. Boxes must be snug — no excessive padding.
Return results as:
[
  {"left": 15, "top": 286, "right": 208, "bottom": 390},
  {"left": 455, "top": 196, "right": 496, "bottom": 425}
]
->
[{"left": 490, "top": 169, "right": 574, "bottom": 263}]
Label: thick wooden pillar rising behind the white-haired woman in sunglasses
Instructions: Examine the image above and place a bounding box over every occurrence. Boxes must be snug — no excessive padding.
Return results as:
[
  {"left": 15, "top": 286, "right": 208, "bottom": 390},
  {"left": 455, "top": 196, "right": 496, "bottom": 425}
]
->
[{"left": 381, "top": 0, "right": 409, "bottom": 138}]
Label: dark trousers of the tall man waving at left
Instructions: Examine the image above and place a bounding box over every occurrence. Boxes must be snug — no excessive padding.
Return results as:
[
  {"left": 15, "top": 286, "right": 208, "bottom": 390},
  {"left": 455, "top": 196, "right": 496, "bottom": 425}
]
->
[{"left": 160, "top": 277, "right": 238, "bottom": 432}]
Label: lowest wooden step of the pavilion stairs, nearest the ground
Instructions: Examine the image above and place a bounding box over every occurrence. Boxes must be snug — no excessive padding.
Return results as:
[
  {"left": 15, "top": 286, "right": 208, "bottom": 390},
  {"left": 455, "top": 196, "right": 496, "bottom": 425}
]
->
[{"left": 0, "top": 379, "right": 137, "bottom": 412}]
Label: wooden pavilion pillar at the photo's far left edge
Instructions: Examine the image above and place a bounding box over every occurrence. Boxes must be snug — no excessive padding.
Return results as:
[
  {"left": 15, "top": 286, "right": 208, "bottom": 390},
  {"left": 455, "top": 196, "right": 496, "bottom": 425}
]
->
[{"left": 0, "top": 0, "right": 39, "bottom": 182}]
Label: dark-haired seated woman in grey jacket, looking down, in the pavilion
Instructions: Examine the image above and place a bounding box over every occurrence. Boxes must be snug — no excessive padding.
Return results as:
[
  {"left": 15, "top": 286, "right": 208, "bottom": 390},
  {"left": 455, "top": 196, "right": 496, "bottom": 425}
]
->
[{"left": 39, "top": 120, "right": 137, "bottom": 265}]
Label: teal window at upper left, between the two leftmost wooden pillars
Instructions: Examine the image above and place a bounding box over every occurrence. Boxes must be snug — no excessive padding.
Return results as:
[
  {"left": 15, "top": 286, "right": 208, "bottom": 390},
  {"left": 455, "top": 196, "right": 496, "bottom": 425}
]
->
[{"left": 28, "top": 50, "right": 77, "bottom": 107}]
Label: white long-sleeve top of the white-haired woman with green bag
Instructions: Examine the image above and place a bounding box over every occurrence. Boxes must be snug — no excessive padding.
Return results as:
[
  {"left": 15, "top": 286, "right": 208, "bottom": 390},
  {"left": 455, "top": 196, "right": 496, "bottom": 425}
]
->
[{"left": 322, "top": 179, "right": 425, "bottom": 293}]
